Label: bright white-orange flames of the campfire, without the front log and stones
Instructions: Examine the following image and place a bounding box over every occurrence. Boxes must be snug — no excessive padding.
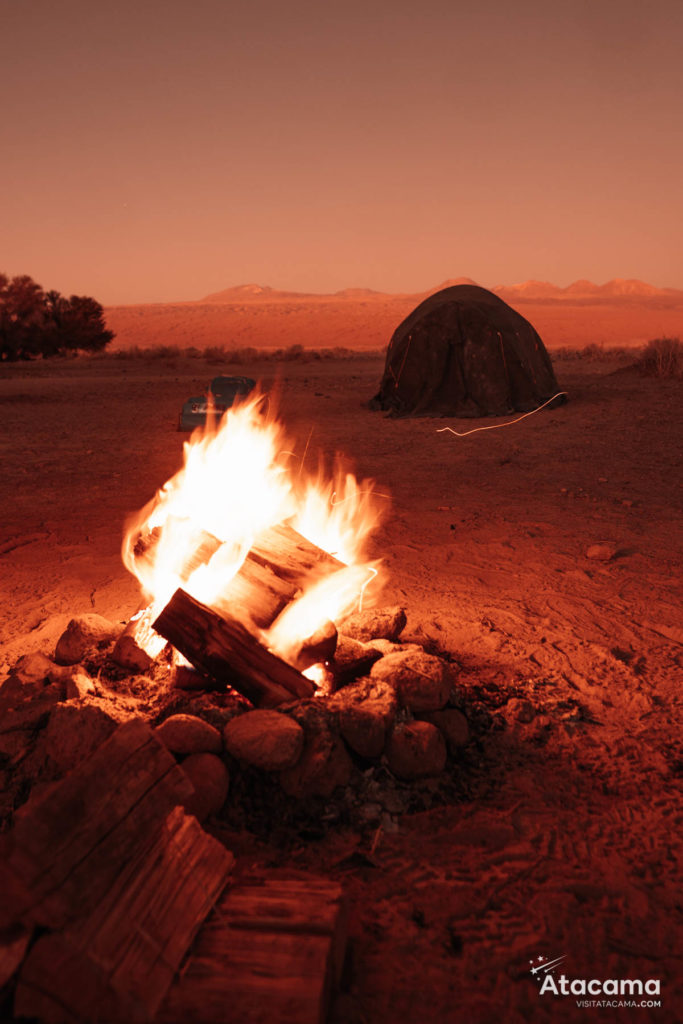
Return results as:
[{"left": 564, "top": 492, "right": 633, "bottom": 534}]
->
[{"left": 122, "top": 395, "right": 386, "bottom": 657}]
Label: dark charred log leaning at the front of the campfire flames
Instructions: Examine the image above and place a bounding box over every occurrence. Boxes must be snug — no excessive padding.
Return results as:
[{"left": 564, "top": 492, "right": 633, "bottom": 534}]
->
[{"left": 154, "top": 589, "right": 315, "bottom": 708}]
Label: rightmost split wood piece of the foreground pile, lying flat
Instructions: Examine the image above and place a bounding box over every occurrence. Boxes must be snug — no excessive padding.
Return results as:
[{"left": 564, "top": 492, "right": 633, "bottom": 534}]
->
[{"left": 157, "top": 879, "right": 346, "bottom": 1024}]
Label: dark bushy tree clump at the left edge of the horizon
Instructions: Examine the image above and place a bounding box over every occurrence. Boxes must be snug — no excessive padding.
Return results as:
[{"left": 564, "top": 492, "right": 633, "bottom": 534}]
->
[{"left": 0, "top": 274, "right": 114, "bottom": 360}]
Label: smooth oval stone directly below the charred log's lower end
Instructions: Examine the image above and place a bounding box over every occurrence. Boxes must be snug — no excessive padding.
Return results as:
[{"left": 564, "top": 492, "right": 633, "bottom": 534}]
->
[{"left": 223, "top": 710, "right": 304, "bottom": 771}]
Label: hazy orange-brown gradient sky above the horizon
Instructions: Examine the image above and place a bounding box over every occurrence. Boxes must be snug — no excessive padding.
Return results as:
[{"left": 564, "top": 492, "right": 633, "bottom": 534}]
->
[{"left": 0, "top": 0, "right": 683, "bottom": 304}]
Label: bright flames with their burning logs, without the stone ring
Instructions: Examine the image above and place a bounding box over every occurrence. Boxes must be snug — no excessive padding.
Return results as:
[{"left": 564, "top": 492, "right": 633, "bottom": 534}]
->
[{"left": 118, "top": 387, "right": 381, "bottom": 707}]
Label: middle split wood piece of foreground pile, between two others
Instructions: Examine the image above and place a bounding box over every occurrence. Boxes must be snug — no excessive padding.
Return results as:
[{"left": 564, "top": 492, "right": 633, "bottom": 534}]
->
[{"left": 14, "top": 808, "right": 233, "bottom": 1021}]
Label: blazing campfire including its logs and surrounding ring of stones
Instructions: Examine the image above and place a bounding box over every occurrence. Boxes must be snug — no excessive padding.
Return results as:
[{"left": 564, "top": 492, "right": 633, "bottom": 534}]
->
[{"left": 0, "top": 387, "right": 468, "bottom": 822}]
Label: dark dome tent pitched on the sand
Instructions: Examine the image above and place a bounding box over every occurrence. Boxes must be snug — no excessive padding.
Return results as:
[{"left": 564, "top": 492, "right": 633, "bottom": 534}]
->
[{"left": 370, "top": 285, "right": 562, "bottom": 417}]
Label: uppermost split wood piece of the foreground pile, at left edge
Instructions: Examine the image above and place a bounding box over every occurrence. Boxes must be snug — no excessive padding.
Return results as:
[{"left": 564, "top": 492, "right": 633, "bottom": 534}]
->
[{"left": 0, "top": 719, "right": 194, "bottom": 928}]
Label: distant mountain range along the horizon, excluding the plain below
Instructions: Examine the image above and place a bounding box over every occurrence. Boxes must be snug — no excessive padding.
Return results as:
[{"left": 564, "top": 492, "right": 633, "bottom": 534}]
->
[{"left": 197, "top": 278, "right": 683, "bottom": 305}]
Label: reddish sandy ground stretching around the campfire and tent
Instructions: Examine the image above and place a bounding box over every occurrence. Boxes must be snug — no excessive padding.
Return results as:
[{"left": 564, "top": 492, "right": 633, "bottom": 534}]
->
[{"left": 0, "top": 359, "right": 683, "bottom": 1024}]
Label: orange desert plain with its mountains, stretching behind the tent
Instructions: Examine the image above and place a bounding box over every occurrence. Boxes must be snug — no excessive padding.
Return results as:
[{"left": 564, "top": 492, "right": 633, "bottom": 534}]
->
[{"left": 105, "top": 278, "right": 683, "bottom": 350}]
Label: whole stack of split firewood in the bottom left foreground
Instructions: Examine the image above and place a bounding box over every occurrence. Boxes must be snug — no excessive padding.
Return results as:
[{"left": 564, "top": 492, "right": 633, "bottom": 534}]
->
[{"left": 0, "top": 720, "right": 345, "bottom": 1024}]
